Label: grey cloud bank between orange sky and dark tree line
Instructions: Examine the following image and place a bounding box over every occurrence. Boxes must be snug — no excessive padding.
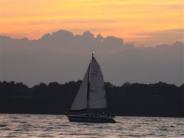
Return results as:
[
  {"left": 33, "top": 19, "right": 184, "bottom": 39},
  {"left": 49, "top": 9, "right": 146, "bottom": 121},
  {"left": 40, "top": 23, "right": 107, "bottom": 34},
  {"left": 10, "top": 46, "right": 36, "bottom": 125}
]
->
[{"left": 0, "top": 30, "right": 184, "bottom": 85}]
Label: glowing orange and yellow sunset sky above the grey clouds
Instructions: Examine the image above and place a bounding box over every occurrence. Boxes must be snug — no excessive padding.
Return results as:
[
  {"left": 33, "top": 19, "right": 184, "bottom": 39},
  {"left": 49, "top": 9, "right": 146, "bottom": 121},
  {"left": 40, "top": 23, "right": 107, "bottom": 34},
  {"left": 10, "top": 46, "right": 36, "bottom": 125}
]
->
[{"left": 0, "top": 0, "right": 184, "bottom": 44}]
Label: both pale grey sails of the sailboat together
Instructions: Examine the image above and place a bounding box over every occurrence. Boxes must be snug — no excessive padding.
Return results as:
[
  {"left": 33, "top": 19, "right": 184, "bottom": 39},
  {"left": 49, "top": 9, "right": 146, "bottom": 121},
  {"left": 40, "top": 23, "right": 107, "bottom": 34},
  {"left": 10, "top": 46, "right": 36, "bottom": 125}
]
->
[{"left": 71, "top": 56, "right": 107, "bottom": 110}]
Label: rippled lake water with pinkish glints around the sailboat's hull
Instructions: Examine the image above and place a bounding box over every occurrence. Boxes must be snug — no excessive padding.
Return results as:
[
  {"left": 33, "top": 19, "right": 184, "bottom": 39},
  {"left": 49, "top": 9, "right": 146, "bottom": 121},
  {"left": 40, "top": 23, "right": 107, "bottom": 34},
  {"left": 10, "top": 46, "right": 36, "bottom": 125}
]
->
[{"left": 0, "top": 114, "right": 184, "bottom": 138}]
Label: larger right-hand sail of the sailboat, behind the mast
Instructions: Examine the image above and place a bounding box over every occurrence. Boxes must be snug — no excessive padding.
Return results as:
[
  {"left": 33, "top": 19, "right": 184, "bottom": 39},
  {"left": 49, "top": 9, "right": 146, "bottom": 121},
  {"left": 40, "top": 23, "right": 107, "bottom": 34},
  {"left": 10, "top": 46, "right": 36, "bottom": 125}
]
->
[{"left": 88, "top": 57, "right": 107, "bottom": 109}]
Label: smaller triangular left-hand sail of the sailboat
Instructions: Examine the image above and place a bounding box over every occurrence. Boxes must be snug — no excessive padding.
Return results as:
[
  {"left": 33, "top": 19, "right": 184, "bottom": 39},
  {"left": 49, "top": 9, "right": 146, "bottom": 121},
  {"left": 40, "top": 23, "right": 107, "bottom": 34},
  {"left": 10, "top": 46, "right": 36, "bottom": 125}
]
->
[{"left": 71, "top": 68, "right": 89, "bottom": 110}]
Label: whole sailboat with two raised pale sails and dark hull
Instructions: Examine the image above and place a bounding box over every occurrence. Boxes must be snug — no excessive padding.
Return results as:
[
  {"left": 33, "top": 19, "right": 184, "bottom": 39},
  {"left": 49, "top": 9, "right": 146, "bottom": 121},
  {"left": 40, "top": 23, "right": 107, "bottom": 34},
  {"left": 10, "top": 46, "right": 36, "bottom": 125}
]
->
[{"left": 68, "top": 52, "right": 115, "bottom": 123}]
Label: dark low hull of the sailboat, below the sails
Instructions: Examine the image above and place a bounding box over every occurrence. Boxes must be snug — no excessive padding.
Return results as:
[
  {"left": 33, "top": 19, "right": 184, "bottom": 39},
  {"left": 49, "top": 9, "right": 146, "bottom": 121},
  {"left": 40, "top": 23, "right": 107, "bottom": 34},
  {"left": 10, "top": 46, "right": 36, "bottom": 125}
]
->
[{"left": 68, "top": 115, "right": 115, "bottom": 123}]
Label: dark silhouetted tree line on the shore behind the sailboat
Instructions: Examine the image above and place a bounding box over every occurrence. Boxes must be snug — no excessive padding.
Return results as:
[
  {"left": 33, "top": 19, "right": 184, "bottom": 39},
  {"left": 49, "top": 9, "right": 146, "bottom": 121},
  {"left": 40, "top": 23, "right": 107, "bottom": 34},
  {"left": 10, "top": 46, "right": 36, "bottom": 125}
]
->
[{"left": 0, "top": 81, "right": 184, "bottom": 117}]
